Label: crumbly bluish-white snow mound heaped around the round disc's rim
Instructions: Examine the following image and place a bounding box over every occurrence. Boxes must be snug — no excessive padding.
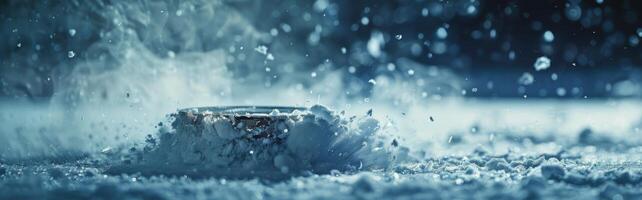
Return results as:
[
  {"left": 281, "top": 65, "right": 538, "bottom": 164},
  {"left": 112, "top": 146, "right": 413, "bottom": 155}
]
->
[{"left": 110, "top": 105, "right": 401, "bottom": 178}]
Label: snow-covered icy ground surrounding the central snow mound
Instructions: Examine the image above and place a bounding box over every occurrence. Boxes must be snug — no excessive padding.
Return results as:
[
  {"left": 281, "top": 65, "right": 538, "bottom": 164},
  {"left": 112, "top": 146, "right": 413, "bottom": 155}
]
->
[{"left": 0, "top": 100, "right": 642, "bottom": 199}]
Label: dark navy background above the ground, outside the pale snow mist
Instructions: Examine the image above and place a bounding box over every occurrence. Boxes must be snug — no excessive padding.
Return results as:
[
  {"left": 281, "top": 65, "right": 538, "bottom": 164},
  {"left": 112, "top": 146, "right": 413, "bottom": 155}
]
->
[{"left": 0, "top": 0, "right": 642, "bottom": 100}]
